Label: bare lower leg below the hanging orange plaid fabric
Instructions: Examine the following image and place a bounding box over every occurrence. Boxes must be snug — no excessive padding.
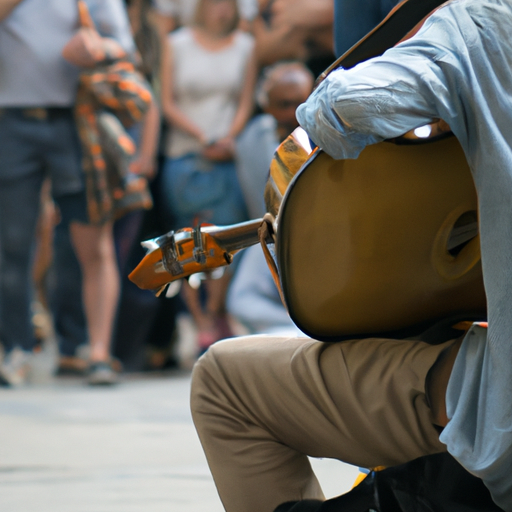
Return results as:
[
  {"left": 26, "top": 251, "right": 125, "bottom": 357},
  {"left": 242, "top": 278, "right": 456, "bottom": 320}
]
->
[{"left": 70, "top": 222, "right": 119, "bottom": 363}]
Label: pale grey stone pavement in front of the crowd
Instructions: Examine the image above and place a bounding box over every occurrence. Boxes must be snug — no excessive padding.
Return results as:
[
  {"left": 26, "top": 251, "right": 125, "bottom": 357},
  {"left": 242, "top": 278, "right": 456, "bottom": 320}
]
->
[{"left": 0, "top": 370, "right": 357, "bottom": 512}]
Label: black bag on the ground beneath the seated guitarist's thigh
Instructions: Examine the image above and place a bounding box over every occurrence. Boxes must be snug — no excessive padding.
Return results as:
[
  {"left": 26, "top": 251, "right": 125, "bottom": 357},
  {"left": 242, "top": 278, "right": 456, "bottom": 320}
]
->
[{"left": 274, "top": 453, "right": 503, "bottom": 512}]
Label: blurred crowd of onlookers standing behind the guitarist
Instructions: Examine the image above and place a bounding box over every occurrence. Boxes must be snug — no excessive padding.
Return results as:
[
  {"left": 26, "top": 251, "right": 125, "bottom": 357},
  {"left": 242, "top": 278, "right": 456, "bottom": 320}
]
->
[{"left": 0, "top": 0, "right": 393, "bottom": 386}]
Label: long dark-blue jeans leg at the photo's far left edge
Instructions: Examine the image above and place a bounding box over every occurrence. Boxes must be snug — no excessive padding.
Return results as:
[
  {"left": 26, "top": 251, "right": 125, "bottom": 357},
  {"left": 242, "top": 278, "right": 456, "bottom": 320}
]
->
[{"left": 0, "top": 109, "right": 45, "bottom": 358}]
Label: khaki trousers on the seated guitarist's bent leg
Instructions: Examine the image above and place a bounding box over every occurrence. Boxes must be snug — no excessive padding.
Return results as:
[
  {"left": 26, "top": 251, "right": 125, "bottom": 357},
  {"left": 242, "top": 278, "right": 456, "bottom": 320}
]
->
[{"left": 191, "top": 336, "right": 451, "bottom": 512}]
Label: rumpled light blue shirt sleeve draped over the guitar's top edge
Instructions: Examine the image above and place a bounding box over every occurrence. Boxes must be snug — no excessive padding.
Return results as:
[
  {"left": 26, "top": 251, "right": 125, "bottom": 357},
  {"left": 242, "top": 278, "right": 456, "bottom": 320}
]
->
[{"left": 297, "top": 33, "right": 450, "bottom": 159}]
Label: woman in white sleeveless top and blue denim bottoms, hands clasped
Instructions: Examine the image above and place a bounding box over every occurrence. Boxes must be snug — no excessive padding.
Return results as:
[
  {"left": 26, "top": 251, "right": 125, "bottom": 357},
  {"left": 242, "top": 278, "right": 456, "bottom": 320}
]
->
[{"left": 160, "top": 0, "right": 257, "bottom": 351}]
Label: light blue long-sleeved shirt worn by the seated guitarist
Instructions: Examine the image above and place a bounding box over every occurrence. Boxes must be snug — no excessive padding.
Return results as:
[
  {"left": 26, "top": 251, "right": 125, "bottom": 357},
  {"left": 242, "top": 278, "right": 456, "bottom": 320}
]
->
[{"left": 297, "top": 0, "right": 512, "bottom": 511}]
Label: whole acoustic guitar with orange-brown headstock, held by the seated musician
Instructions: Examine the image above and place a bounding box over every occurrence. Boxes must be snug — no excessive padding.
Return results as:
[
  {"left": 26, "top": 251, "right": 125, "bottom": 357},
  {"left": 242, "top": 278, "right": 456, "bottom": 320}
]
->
[{"left": 130, "top": 0, "right": 486, "bottom": 341}]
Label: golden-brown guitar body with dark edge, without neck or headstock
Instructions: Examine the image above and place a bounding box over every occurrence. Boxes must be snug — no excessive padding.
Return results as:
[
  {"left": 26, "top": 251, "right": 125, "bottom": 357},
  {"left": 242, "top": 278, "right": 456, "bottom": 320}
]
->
[{"left": 276, "top": 136, "right": 486, "bottom": 341}]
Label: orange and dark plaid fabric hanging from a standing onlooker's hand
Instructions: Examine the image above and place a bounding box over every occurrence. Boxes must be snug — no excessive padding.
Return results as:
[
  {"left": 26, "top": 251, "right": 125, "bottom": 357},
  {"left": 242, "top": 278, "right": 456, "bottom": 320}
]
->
[{"left": 75, "top": 0, "right": 152, "bottom": 224}]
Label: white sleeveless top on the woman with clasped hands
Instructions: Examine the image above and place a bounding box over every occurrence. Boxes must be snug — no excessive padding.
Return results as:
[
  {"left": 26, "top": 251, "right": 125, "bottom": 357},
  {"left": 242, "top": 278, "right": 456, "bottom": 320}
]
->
[{"left": 165, "top": 27, "right": 254, "bottom": 158}]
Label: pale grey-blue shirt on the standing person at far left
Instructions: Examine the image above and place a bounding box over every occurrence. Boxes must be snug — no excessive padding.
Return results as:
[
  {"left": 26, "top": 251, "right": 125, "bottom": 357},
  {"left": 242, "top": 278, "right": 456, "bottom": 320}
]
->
[{"left": 0, "top": 0, "right": 135, "bottom": 107}]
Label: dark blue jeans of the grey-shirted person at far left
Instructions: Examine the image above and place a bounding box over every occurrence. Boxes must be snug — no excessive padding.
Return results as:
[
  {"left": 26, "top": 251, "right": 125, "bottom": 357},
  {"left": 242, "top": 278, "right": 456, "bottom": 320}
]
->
[{"left": 0, "top": 108, "right": 84, "bottom": 352}]
